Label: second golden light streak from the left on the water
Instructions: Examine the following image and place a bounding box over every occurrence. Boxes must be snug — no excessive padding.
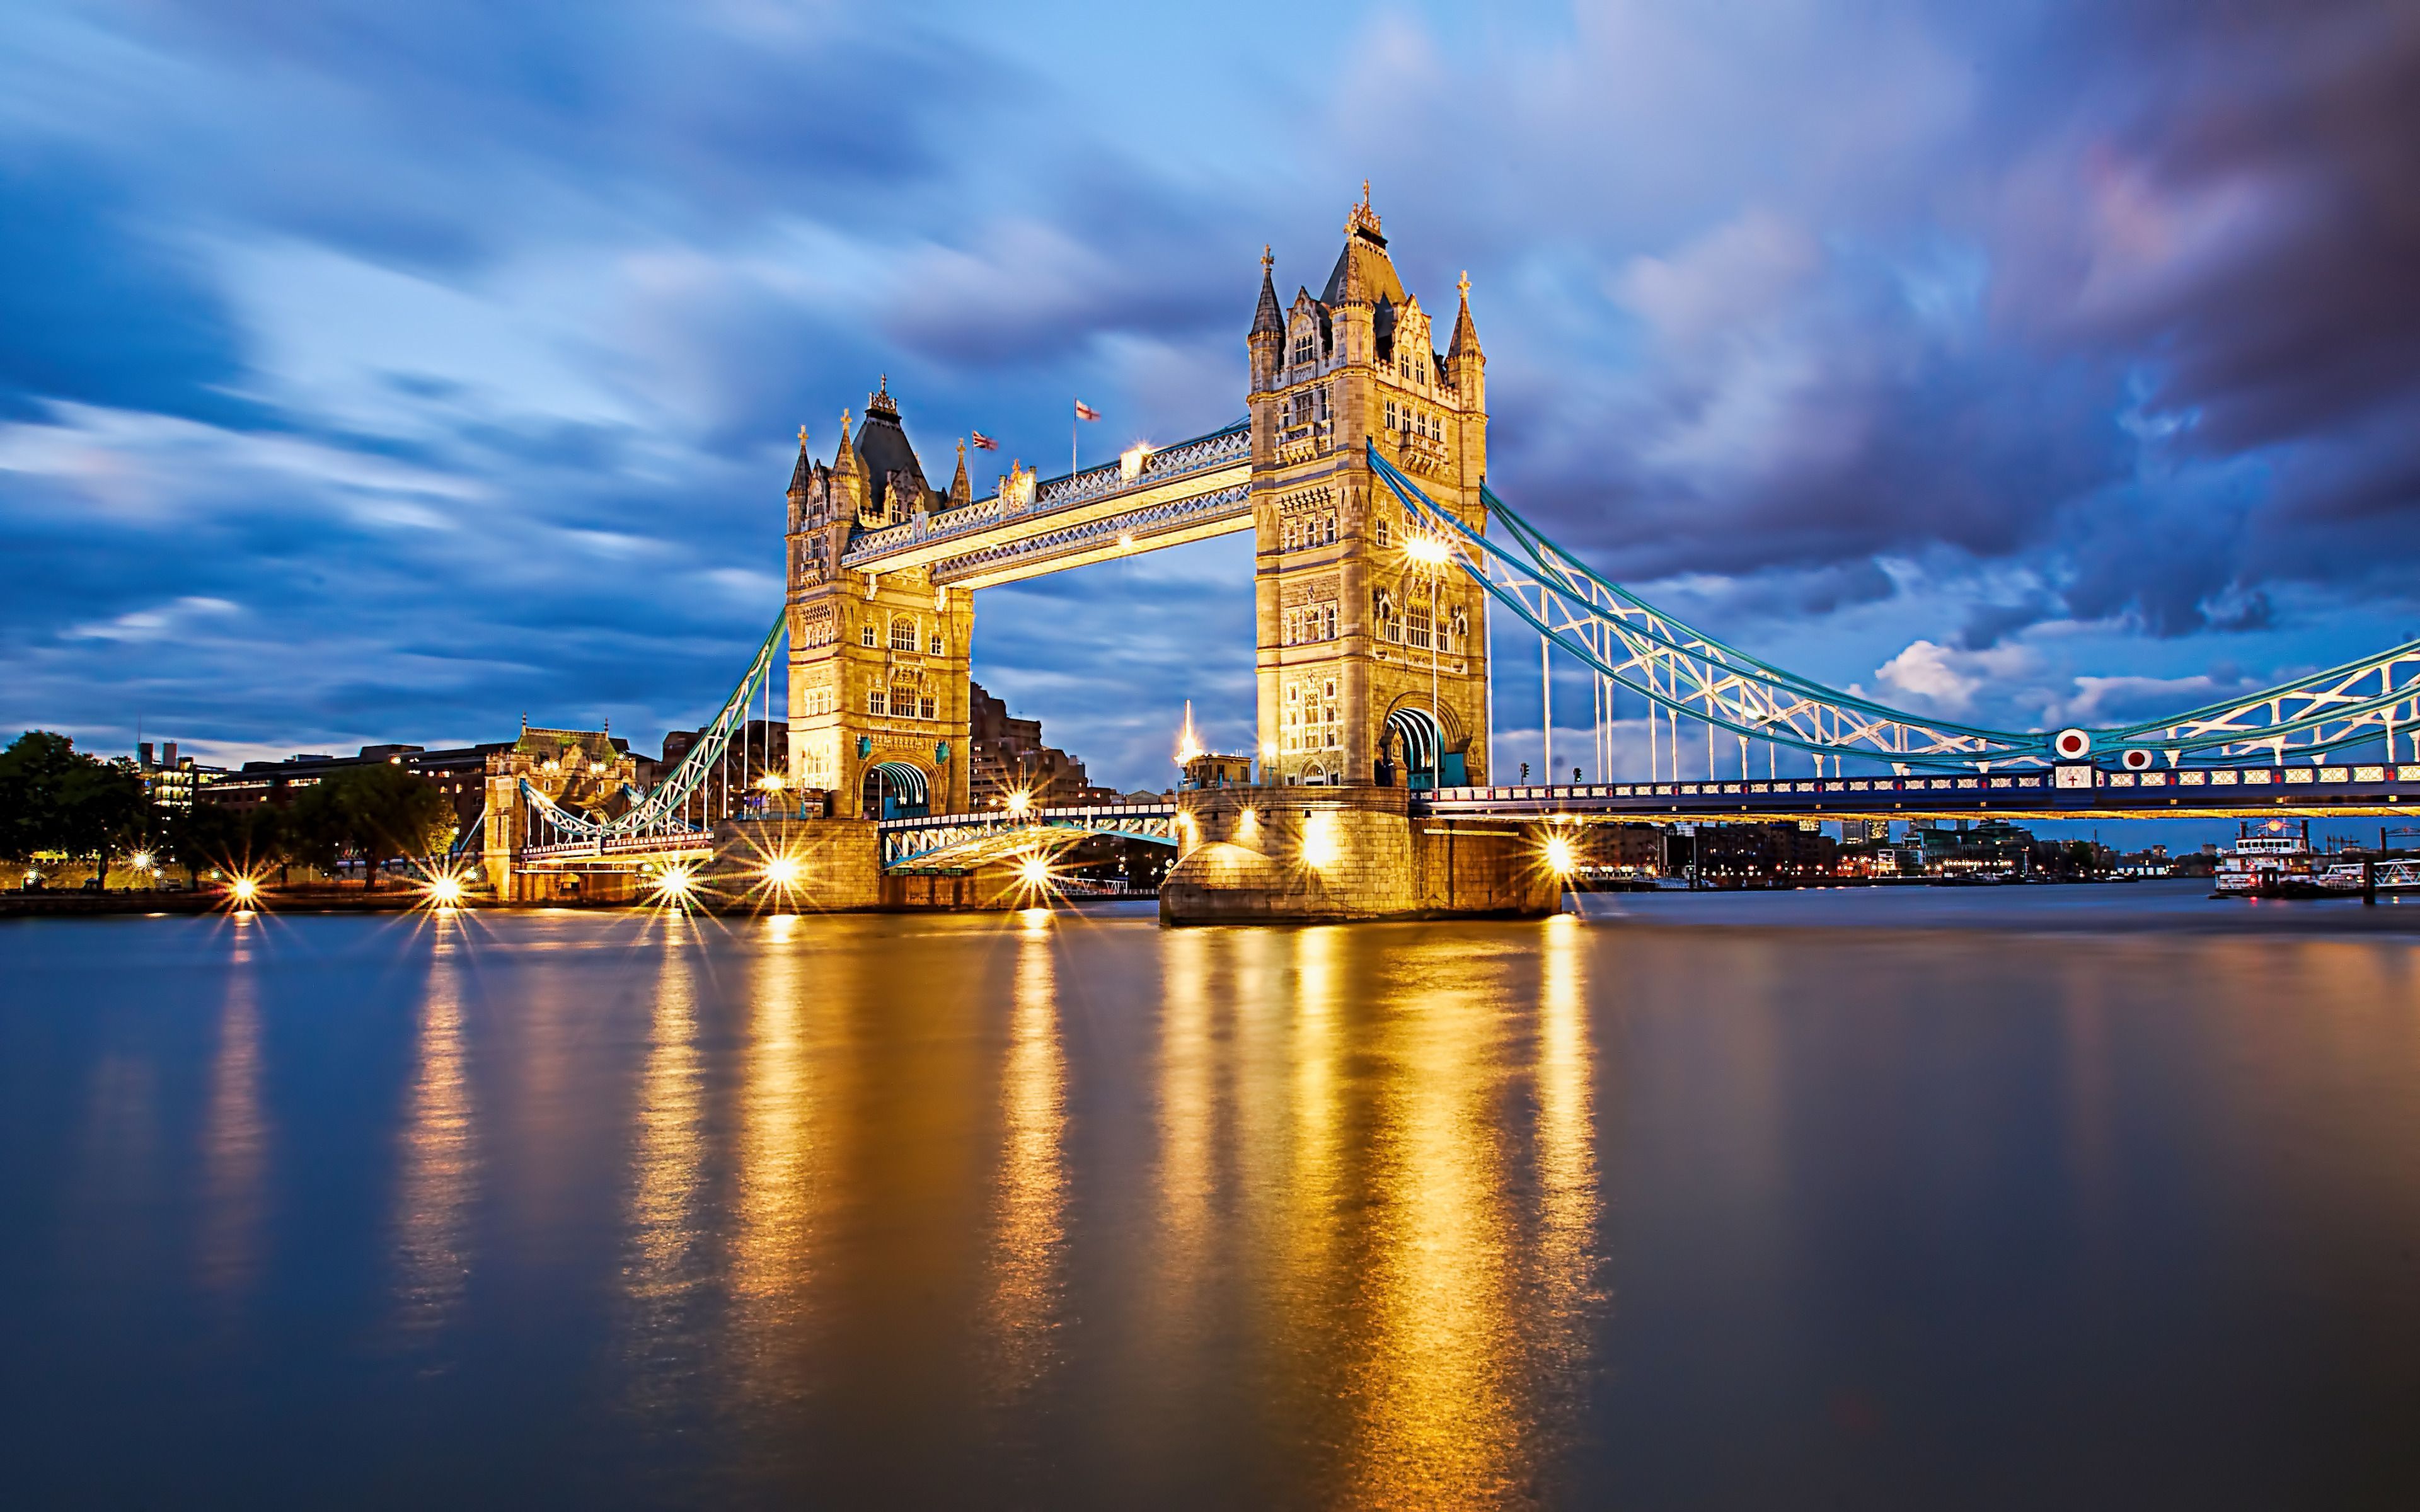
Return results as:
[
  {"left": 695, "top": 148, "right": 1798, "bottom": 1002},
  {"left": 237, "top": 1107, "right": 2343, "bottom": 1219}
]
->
[{"left": 395, "top": 919, "right": 479, "bottom": 1369}]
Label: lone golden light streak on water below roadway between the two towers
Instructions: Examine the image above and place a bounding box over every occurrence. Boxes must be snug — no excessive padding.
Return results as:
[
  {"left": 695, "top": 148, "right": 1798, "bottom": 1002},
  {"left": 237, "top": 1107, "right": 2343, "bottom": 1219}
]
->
[{"left": 985, "top": 912, "right": 1067, "bottom": 1399}]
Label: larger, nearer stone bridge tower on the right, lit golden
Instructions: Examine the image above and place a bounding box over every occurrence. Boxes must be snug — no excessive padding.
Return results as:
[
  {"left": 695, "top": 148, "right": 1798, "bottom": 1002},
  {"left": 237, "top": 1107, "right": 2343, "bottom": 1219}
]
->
[{"left": 1247, "top": 184, "right": 1489, "bottom": 789}]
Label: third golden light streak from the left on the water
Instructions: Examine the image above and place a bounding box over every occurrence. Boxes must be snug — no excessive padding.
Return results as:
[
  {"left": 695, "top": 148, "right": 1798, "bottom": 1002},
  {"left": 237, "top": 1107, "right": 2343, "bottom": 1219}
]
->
[{"left": 622, "top": 929, "right": 704, "bottom": 1423}]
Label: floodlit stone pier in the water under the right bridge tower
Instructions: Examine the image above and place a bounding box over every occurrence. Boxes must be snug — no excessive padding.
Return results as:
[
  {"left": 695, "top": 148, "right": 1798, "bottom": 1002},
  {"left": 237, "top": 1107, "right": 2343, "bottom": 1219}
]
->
[{"left": 1159, "top": 786, "right": 1564, "bottom": 924}]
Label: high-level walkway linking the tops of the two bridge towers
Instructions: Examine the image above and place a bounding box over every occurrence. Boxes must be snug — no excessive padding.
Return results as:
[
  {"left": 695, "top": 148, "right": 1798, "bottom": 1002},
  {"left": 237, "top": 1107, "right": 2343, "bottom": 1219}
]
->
[{"left": 839, "top": 421, "right": 1251, "bottom": 588}]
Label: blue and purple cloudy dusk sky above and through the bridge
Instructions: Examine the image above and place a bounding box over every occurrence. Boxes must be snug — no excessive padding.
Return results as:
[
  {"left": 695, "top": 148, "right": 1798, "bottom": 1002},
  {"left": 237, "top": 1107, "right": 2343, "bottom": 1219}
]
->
[{"left": 0, "top": 0, "right": 2420, "bottom": 803}]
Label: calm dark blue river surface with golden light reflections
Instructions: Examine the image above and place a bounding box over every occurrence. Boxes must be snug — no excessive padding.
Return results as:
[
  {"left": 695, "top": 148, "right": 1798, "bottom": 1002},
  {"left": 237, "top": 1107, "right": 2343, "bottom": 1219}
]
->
[{"left": 0, "top": 885, "right": 2420, "bottom": 1507}]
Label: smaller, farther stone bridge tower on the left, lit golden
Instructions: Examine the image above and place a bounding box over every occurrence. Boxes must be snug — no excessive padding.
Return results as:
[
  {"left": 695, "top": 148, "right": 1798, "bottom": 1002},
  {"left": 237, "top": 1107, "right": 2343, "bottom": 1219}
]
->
[{"left": 789, "top": 377, "right": 976, "bottom": 818}]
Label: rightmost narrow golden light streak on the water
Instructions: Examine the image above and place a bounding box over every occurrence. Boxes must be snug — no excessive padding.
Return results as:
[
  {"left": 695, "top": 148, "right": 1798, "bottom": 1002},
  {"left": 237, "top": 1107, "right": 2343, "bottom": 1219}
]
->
[{"left": 1536, "top": 915, "right": 1597, "bottom": 1367}]
